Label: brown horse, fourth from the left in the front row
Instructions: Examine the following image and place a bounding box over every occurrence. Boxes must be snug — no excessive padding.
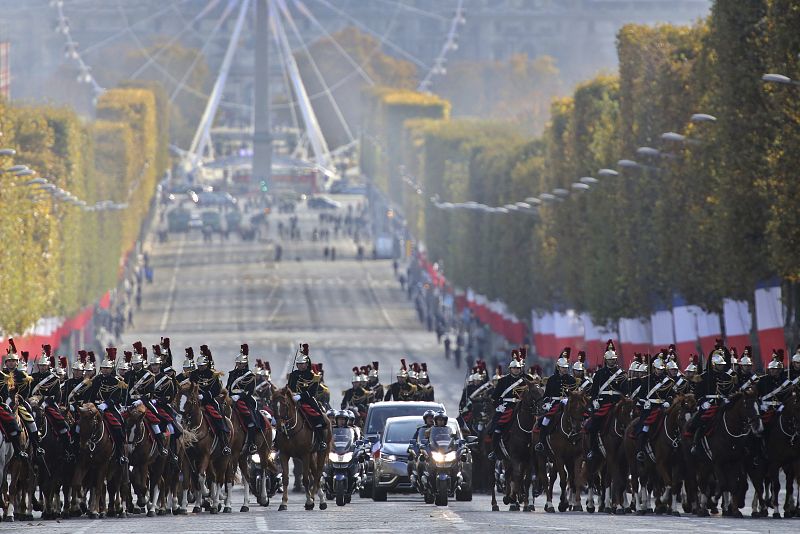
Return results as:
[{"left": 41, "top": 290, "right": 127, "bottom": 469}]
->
[{"left": 125, "top": 403, "right": 168, "bottom": 517}]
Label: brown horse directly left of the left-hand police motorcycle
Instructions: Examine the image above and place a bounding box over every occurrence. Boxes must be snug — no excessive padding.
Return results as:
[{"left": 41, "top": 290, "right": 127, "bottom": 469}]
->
[{"left": 272, "top": 387, "right": 331, "bottom": 511}]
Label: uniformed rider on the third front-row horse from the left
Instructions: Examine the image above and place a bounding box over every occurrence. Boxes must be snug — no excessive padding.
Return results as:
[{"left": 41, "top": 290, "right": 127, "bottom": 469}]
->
[{"left": 84, "top": 347, "right": 128, "bottom": 464}]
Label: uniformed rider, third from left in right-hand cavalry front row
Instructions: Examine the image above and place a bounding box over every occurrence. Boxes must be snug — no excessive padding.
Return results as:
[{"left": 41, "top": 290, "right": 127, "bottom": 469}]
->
[{"left": 586, "top": 339, "right": 628, "bottom": 459}]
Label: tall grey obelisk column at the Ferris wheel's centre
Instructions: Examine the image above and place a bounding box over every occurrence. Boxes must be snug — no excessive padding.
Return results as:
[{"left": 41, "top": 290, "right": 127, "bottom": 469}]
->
[{"left": 253, "top": 0, "right": 272, "bottom": 195}]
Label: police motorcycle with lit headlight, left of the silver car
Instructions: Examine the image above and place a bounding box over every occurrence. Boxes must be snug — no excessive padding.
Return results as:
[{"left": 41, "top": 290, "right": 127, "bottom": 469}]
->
[{"left": 325, "top": 414, "right": 364, "bottom": 506}]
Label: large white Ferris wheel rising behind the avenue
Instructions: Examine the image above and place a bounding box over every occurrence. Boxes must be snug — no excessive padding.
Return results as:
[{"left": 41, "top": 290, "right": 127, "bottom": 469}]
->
[{"left": 46, "top": 0, "right": 465, "bottom": 169}]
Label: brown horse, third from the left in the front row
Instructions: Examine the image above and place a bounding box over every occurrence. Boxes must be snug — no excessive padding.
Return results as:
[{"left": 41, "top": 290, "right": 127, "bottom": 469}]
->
[{"left": 71, "top": 402, "right": 128, "bottom": 519}]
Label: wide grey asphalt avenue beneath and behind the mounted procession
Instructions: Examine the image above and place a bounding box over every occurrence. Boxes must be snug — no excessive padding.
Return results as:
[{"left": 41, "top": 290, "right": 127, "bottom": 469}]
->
[{"left": 0, "top": 199, "right": 800, "bottom": 534}]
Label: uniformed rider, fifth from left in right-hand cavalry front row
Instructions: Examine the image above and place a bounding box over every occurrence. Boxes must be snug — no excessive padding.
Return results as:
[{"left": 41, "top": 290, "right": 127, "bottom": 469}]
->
[{"left": 686, "top": 346, "right": 737, "bottom": 455}]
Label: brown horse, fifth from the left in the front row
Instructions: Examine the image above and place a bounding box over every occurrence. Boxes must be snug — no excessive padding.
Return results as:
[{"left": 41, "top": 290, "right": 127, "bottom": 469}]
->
[{"left": 180, "top": 383, "right": 235, "bottom": 514}]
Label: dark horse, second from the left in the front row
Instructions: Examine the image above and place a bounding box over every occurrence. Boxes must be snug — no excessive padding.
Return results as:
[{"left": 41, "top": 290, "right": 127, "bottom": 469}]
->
[{"left": 29, "top": 396, "right": 73, "bottom": 519}]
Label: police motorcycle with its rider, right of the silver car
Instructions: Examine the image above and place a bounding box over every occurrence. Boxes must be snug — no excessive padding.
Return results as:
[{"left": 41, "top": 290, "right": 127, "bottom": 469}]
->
[{"left": 419, "top": 412, "right": 472, "bottom": 506}]
